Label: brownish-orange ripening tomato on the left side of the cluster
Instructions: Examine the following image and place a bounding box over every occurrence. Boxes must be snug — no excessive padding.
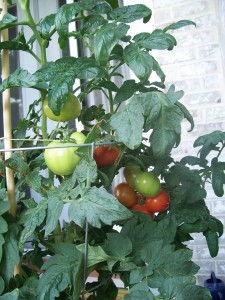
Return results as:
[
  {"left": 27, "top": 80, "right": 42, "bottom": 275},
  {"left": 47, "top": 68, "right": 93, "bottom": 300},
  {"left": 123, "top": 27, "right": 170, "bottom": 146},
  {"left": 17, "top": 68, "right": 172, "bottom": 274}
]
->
[{"left": 114, "top": 182, "right": 138, "bottom": 208}]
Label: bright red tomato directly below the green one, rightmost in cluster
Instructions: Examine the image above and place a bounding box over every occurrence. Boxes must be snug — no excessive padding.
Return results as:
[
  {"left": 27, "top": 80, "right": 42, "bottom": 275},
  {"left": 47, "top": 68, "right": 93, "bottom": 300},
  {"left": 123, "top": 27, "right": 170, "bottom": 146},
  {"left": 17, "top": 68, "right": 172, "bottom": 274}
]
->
[{"left": 145, "top": 190, "right": 170, "bottom": 212}]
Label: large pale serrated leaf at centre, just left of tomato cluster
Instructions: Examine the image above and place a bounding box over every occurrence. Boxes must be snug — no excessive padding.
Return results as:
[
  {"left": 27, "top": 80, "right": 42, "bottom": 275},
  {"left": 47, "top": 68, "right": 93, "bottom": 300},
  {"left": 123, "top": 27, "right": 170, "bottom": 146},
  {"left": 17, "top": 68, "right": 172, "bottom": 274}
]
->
[{"left": 68, "top": 187, "right": 132, "bottom": 228}]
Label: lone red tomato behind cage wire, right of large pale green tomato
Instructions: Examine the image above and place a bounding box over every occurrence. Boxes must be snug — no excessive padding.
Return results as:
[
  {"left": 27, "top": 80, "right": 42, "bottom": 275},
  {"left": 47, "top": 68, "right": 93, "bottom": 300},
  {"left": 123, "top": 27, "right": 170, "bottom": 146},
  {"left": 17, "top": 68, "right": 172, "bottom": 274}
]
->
[{"left": 94, "top": 145, "right": 120, "bottom": 168}]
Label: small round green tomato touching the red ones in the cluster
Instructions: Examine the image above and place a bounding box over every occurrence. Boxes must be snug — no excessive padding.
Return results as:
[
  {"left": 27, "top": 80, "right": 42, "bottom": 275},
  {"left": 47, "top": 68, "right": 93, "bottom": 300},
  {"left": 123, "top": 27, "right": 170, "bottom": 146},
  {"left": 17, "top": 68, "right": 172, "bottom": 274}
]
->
[{"left": 134, "top": 172, "right": 161, "bottom": 197}]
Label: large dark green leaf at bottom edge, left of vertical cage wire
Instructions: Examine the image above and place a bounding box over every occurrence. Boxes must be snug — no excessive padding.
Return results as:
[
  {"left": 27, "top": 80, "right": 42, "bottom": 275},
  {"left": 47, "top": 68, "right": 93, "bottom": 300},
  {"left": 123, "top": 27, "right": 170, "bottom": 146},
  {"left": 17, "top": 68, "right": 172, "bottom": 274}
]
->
[{"left": 38, "top": 243, "right": 83, "bottom": 300}]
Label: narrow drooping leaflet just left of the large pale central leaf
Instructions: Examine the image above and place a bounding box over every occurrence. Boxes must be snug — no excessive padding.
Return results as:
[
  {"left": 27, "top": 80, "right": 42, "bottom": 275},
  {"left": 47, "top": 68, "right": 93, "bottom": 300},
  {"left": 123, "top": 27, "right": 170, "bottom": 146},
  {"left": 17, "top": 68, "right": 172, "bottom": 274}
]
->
[{"left": 45, "top": 189, "right": 64, "bottom": 235}]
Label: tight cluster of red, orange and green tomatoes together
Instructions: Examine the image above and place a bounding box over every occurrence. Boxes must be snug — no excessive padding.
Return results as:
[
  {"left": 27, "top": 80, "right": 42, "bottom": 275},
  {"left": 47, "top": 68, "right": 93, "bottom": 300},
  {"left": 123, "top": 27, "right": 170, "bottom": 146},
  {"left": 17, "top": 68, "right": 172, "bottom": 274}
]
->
[{"left": 114, "top": 166, "right": 170, "bottom": 218}]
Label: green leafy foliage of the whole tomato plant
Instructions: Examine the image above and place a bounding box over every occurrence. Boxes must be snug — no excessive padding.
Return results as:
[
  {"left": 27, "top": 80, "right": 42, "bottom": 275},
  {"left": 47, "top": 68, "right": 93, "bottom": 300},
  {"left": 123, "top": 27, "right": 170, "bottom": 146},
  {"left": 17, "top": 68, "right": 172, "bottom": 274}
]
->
[{"left": 0, "top": 0, "right": 222, "bottom": 300}]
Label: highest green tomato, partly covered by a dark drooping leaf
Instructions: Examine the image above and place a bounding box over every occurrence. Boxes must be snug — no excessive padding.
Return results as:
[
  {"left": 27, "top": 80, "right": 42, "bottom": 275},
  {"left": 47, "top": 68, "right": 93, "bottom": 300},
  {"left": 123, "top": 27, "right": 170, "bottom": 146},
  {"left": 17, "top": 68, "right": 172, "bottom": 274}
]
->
[{"left": 43, "top": 94, "right": 81, "bottom": 122}]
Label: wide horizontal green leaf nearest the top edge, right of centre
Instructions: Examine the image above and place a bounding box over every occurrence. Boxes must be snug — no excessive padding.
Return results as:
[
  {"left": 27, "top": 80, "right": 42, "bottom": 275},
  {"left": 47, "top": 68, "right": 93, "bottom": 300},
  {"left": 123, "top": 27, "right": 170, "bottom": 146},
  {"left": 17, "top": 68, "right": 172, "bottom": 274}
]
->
[{"left": 108, "top": 4, "right": 152, "bottom": 23}]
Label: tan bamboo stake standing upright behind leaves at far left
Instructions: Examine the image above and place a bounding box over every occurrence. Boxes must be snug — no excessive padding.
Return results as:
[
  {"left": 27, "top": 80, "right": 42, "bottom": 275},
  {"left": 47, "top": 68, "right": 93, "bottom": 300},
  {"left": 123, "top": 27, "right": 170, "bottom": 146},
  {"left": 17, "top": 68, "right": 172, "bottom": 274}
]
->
[{"left": 0, "top": 0, "right": 20, "bottom": 275}]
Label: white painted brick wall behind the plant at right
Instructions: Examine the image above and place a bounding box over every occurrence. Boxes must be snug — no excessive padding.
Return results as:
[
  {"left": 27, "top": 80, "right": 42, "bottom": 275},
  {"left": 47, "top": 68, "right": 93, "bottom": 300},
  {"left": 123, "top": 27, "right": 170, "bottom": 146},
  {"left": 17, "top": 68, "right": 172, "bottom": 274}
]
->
[{"left": 152, "top": 0, "right": 225, "bottom": 284}]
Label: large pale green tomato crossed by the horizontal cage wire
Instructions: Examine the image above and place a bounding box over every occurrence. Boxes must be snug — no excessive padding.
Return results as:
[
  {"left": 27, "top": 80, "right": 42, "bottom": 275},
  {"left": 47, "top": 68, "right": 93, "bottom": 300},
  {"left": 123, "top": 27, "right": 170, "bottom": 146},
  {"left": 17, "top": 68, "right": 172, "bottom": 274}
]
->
[{"left": 44, "top": 141, "right": 80, "bottom": 176}]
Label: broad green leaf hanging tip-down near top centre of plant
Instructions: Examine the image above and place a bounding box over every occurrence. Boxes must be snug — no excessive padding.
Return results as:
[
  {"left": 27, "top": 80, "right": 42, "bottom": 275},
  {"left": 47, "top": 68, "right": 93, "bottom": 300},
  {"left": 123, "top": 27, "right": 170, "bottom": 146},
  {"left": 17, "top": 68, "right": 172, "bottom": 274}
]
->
[{"left": 93, "top": 23, "right": 129, "bottom": 66}]
